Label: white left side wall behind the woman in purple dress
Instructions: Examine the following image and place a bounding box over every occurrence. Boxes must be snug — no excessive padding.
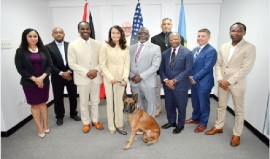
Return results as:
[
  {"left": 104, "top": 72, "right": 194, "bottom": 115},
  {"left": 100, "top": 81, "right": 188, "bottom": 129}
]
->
[{"left": 1, "top": 0, "right": 52, "bottom": 131}]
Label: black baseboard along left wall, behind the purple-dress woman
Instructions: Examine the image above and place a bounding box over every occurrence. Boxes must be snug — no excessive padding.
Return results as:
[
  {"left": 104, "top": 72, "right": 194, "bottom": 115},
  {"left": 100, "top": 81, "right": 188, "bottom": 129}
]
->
[{"left": 1, "top": 100, "right": 53, "bottom": 137}]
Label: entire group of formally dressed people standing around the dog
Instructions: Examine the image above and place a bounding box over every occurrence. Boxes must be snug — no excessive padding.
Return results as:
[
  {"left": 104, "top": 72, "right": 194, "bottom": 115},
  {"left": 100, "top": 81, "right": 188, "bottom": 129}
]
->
[{"left": 15, "top": 18, "right": 256, "bottom": 146}]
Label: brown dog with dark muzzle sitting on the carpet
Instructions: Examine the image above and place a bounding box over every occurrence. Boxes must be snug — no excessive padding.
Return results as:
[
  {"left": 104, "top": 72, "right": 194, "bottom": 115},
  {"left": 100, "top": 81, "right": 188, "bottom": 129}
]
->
[{"left": 123, "top": 93, "right": 160, "bottom": 150}]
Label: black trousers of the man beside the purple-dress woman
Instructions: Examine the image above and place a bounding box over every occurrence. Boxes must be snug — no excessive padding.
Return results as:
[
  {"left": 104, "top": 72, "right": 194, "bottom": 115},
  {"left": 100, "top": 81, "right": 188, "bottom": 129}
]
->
[{"left": 51, "top": 77, "right": 78, "bottom": 119}]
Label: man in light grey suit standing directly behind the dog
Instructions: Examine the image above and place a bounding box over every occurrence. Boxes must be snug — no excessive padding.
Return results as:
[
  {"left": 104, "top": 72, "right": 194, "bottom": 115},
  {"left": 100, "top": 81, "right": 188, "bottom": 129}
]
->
[{"left": 129, "top": 27, "right": 161, "bottom": 117}]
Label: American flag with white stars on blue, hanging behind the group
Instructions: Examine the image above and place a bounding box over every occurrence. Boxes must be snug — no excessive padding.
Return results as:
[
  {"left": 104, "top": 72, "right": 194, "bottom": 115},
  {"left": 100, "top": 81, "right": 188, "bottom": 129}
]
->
[{"left": 130, "top": 1, "right": 143, "bottom": 45}]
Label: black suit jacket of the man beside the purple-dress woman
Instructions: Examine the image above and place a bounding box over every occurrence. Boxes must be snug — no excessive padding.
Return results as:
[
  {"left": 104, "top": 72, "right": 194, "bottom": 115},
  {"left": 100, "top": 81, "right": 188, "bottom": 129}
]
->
[{"left": 46, "top": 41, "right": 72, "bottom": 79}]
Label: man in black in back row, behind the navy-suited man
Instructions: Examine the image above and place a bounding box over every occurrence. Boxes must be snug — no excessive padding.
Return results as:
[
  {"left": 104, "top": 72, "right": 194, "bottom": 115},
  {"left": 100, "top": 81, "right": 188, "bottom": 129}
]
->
[{"left": 151, "top": 18, "right": 184, "bottom": 116}]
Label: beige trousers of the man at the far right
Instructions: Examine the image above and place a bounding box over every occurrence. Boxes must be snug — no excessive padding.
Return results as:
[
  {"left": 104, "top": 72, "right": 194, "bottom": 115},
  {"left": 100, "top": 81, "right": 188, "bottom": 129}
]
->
[{"left": 215, "top": 86, "right": 246, "bottom": 136}]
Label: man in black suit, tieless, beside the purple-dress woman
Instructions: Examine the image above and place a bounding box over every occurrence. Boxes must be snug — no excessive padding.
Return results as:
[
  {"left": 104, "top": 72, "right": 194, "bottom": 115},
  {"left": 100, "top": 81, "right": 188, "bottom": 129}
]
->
[{"left": 46, "top": 27, "right": 81, "bottom": 126}]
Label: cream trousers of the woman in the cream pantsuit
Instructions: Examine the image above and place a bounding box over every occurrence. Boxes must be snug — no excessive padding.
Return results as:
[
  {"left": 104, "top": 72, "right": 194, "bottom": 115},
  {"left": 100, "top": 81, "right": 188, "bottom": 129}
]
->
[{"left": 104, "top": 82, "right": 125, "bottom": 130}]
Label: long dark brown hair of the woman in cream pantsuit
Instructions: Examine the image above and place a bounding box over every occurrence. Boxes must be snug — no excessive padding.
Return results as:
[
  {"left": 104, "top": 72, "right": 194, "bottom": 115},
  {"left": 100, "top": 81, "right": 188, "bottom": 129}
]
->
[{"left": 106, "top": 25, "right": 127, "bottom": 50}]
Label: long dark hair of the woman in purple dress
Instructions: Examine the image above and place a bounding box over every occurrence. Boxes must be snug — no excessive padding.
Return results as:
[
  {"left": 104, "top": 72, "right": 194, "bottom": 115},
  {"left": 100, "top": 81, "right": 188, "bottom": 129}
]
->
[{"left": 20, "top": 28, "right": 46, "bottom": 51}]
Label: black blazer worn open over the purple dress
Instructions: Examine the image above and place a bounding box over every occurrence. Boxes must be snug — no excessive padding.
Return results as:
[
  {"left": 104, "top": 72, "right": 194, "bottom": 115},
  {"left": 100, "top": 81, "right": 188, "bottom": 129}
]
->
[{"left": 15, "top": 48, "right": 52, "bottom": 87}]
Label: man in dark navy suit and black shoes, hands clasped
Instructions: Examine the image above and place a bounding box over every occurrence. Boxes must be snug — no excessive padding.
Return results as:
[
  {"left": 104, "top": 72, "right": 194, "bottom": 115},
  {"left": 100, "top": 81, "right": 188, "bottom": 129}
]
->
[{"left": 159, "top": 33, "right": 193, "bottom": 134}]
